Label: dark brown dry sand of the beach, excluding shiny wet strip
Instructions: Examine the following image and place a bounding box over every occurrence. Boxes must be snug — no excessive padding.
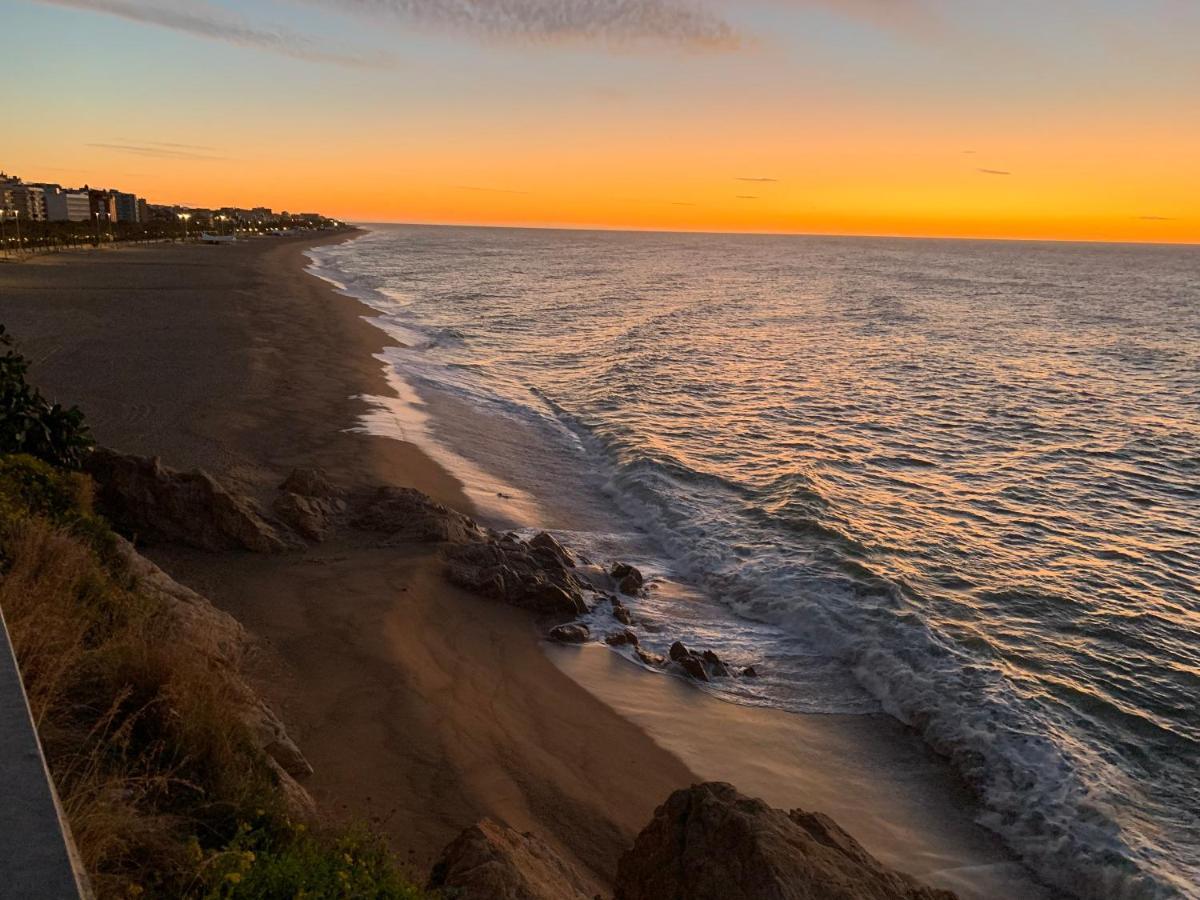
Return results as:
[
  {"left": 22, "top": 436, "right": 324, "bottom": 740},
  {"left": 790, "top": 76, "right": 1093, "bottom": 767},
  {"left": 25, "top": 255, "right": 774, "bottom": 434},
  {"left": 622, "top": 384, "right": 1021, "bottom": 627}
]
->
[{"left": 0, "top": 235, "right": 694, "bottom": 890}]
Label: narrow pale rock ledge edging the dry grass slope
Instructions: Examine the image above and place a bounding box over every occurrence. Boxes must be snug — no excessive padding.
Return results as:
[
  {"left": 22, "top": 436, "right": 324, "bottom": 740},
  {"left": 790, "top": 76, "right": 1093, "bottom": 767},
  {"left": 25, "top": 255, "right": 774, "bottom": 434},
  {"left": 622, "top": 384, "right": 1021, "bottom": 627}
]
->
[{"left": 115, "top": 538, "right": 314, "bottom": 816}]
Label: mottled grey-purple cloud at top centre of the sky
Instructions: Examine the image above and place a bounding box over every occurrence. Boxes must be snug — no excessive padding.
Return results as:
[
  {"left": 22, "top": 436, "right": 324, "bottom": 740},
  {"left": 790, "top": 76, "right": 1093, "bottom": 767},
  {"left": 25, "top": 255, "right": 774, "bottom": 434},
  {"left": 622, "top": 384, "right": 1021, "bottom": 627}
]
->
[{"left": 297, "top": 0, "right": 742, "bottom": 49}]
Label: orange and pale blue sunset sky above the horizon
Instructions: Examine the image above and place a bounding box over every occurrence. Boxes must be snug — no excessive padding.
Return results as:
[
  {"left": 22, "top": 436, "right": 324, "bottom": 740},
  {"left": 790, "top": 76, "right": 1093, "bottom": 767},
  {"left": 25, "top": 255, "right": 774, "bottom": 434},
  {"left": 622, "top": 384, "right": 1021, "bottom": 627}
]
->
[{"left": 0, "top": 0, "right": 1200, "bottom": 242}]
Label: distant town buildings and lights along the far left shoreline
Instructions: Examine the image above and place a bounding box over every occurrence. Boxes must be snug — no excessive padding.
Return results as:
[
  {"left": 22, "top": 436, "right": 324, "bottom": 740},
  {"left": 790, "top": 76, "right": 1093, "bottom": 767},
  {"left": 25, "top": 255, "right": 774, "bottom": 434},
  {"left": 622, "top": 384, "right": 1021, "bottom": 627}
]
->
[{"left": 0, "top": 172, "right": 341, "bottom": 253}]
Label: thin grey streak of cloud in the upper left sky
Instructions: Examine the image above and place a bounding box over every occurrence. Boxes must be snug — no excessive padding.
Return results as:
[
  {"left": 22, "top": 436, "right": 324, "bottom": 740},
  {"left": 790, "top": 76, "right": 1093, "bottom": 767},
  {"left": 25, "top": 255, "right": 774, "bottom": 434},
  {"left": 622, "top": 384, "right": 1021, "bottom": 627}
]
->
[{"left": 41, "top": 0, "right": 394, "bottom": 68}]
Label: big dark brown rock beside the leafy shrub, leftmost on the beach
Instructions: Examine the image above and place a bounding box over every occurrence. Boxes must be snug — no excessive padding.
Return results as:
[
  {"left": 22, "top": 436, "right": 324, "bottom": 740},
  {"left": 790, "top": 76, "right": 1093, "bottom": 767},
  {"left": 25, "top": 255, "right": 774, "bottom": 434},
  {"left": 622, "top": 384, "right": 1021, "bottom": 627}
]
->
[{"left": 86, "top": 448, "right": 294, "bottom": 553}]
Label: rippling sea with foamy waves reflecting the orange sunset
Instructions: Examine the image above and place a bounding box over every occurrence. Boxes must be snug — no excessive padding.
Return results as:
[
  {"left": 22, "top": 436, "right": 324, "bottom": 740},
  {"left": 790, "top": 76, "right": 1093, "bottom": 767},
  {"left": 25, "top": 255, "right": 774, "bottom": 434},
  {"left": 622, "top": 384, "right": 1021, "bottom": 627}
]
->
[{"left": 312, "top": 227, "right": 1200, "bottom": 899}]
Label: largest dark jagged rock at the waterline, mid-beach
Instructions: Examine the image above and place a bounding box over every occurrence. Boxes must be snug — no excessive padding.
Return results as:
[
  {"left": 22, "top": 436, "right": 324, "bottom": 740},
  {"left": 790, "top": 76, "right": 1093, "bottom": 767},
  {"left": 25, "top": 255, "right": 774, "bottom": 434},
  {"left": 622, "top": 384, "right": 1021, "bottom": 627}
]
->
[{"left": 446, "top": 534, "right": 589, "bottom": 618}]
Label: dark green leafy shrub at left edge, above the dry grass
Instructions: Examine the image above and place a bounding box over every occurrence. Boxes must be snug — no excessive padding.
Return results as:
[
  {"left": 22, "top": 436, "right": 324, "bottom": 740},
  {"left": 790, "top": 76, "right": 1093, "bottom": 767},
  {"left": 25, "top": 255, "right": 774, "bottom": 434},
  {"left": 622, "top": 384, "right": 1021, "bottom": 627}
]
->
[{"left": 0, "top": 325, "right": 92, "bottom": 469}]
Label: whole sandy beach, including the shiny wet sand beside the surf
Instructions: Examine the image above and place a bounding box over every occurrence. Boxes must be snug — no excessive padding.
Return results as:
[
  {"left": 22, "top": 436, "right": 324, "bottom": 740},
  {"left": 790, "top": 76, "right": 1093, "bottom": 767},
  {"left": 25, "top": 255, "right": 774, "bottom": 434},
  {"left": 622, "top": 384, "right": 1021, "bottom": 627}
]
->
[{"left": 0, "top": 234, "right": 1039, "bottom": 896}]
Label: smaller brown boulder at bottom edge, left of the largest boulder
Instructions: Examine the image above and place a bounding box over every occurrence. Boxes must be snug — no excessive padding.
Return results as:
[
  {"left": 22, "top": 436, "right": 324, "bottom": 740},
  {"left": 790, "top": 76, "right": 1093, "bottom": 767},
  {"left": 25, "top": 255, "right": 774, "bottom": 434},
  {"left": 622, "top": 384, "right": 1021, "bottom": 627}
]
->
[{"left": 427, "top": 818, "right": 592, "bottom": 900}]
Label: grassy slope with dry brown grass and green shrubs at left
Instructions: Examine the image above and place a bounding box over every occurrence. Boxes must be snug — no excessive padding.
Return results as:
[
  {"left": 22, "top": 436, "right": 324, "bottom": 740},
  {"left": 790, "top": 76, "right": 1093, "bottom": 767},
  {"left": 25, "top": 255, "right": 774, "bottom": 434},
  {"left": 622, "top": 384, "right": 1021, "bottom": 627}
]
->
[{"left": 0, "top": 332, "right": 424, "bottom": 900}]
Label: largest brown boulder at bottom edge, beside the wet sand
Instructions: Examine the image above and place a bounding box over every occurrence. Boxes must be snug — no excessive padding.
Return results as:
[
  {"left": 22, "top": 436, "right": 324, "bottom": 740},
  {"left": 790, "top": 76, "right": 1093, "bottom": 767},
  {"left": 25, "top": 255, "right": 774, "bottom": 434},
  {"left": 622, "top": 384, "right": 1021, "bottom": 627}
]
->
[{"left": 614, "top": 782, "right": 955, "bottom": 900}]
